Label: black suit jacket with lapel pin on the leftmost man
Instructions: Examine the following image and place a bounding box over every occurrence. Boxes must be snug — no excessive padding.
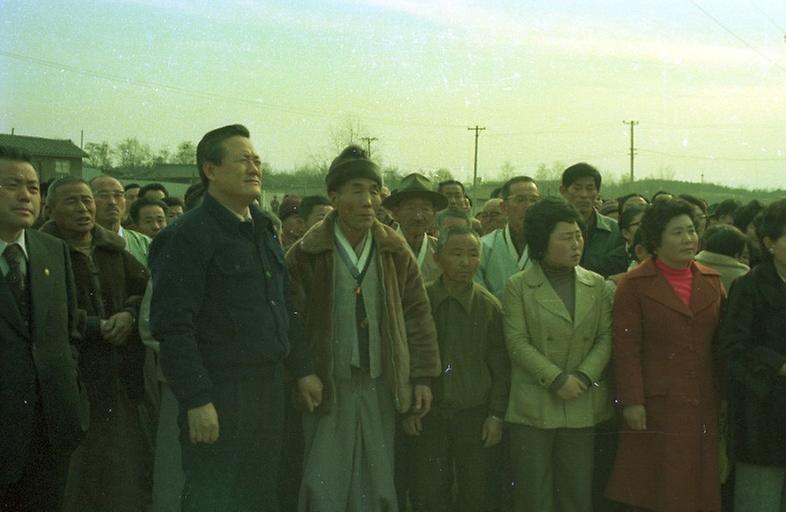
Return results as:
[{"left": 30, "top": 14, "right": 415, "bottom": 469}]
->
[{"left": 0, "top": 230, "right": 89, "bottom": 487}]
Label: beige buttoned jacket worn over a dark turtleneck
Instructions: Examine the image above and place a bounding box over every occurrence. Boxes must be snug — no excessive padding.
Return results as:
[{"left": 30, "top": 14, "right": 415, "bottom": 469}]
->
[{"left": 502, "top": 264, "right": 612, "bottom": 428}]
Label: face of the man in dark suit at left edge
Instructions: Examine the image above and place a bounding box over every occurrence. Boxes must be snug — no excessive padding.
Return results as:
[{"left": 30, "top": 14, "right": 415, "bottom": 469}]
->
[{"left": 0, "top": 159, "right": 41, "bottom": 241}]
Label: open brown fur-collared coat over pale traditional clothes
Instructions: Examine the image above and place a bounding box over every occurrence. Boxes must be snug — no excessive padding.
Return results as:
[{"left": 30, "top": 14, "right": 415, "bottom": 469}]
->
[{"left": 287, "top": 212, "right": 441, "bottom": 414}]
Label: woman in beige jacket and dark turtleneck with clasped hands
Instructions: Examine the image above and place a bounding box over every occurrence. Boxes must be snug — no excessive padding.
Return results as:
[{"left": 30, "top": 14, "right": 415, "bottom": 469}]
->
[{"left": 503, "top": 198, "right": 612, "bottom": 512}]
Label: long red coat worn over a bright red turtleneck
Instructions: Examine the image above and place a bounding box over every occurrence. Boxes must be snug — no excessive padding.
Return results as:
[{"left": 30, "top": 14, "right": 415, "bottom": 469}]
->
[{"left": 607, "top": 259, "right": 724, "bottom": 512}]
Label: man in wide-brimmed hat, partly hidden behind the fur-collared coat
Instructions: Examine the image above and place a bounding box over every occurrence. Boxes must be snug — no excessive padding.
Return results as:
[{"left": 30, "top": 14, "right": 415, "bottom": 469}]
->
[{"left": 382, "top": 173, "right": 448, "bottom": 283}]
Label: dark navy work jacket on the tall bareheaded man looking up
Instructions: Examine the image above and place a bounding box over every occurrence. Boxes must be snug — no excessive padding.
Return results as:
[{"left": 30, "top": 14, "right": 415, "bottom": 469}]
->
[{"left": 148, "top": 194, "right": 313, "bottom": 409}]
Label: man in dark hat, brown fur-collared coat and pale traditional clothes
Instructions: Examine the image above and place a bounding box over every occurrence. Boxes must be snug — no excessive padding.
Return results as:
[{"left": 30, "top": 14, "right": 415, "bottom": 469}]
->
[{"left": 287, "top": 146, "right": 440, "bottom": 512}]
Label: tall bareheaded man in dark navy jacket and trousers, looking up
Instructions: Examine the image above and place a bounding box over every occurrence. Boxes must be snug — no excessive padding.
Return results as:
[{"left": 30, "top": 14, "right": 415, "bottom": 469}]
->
[{"left": 149, "top": 125, "right": 322, "bottom": 512}]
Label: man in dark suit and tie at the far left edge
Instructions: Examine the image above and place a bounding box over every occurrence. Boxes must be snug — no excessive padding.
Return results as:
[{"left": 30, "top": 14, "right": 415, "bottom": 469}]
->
[{"left": 0, "top": 146, "right": 88, "bottom": 511}]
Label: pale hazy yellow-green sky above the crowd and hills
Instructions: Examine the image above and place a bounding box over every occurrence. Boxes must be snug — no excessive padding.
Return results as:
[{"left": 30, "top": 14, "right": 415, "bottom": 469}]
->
[{"left": 0, "top": 0, "right": 786, "bottom": 188}]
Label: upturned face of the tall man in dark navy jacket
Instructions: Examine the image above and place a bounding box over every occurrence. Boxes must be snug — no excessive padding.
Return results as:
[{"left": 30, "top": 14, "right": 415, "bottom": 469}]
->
[{"left": 204, "top": 135, "right": 262, "bottom": 205}]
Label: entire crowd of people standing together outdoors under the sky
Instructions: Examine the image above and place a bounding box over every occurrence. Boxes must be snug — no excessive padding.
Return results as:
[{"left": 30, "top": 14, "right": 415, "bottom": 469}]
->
[{"left": 0, "top": 125, "right": 786, "bottom": 512}]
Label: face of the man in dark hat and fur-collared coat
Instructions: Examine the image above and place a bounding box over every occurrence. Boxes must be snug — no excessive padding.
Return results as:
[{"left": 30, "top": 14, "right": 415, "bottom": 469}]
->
[{"left": 329, "top": 178, "right": 382, "bottom": 232}]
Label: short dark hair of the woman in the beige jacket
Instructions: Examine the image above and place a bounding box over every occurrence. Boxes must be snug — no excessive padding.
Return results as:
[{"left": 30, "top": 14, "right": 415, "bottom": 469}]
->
[{"left": 524, "top": 196, "right": 584, "bottom": 261}]
